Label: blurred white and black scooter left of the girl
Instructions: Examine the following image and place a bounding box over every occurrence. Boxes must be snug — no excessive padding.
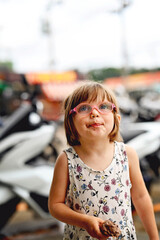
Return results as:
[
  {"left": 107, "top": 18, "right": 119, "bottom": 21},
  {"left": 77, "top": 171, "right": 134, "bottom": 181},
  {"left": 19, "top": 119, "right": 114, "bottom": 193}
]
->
[{"left": 0, "top": 80, "right": 58, "bottom": 229}]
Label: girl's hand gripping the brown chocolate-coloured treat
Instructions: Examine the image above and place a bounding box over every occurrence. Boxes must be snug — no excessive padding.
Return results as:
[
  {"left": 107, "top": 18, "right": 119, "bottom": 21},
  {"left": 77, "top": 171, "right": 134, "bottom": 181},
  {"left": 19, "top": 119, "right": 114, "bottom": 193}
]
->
[{"left": 85, "top": 216, "right": 107, "bottom": 240}]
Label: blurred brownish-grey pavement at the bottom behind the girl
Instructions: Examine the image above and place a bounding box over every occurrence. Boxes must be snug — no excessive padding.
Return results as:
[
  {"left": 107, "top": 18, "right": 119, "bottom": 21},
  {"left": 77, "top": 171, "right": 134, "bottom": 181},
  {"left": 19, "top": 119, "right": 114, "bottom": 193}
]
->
[{"left": 0, "top": 201, "right": 160, "bottom": 240}]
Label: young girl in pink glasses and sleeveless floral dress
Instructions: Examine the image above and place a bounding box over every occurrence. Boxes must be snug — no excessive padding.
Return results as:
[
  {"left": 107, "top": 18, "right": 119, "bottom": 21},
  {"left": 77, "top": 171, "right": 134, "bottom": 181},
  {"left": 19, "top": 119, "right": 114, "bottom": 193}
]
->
[{"left": 49, "top": 82, "right": 159, "bottom": 240}]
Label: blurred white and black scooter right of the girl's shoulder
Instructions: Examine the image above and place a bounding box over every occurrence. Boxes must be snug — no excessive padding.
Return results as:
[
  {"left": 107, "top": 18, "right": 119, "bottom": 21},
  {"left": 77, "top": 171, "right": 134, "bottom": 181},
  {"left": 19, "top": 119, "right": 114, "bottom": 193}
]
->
[{"left": 121, "top": 122, "right": 160, "bottom": 191}]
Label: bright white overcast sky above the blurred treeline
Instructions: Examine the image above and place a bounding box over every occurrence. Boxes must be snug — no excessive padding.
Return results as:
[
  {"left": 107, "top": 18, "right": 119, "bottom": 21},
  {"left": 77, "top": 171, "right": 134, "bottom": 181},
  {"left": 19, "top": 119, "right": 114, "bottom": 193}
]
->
[{"left": 0, "top": 0, "right": 160, "bottom": 73}]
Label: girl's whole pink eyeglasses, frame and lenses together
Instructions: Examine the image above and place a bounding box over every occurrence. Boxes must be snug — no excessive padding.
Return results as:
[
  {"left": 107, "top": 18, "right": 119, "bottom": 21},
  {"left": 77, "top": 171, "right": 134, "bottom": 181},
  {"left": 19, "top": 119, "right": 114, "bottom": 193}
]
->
[{"left": 69, "top": 102, "right": 116, "bottom": 115}]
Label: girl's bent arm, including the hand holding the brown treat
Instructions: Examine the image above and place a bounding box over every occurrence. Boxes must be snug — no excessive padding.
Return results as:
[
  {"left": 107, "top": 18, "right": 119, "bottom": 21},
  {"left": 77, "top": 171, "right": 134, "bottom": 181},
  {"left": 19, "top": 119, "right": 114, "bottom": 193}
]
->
[{"left": 48, "top": 153, "right": 105, "bottom": 239}]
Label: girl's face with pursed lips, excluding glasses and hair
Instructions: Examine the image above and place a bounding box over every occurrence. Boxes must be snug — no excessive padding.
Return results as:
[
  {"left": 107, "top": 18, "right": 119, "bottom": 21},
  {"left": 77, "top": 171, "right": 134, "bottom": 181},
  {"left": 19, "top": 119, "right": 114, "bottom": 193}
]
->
[{"left": 73, "top": 100, "right": 114, "bottom": 142}]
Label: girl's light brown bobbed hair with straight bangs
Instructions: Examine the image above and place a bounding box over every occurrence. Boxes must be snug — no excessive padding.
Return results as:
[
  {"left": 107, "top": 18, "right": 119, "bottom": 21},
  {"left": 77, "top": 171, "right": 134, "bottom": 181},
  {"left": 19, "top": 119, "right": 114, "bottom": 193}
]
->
[{"left": 64, "top": 81, "right": 123, "bottom": 146}]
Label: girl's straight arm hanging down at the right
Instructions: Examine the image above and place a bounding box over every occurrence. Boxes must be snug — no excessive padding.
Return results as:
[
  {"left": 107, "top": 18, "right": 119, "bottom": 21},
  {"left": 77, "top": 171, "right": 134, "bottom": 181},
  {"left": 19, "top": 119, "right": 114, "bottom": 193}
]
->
[{"left": 126, "top": 146, "right": 159, "bottom": 240}]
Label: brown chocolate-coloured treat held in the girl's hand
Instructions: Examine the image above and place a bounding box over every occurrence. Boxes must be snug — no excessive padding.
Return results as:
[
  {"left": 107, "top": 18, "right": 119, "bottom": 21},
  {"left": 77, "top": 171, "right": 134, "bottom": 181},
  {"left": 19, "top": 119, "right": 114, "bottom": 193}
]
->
[{"left": 100, "top": 220, "right": 121, "bottom": 238}]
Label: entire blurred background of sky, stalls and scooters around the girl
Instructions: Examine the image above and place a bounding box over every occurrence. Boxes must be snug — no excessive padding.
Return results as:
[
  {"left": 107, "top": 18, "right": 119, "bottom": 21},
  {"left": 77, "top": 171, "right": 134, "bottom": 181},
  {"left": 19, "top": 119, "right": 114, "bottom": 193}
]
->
[{"left": 0, "top": 0, "right": 160, "bottom": 240}]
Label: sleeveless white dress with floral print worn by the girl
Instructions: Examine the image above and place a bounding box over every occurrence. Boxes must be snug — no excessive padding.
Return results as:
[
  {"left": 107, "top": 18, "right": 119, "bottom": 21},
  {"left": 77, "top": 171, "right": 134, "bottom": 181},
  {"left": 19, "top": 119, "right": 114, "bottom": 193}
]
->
[{"left": 63, "top": 141, "right": 137, "bottom": 240}]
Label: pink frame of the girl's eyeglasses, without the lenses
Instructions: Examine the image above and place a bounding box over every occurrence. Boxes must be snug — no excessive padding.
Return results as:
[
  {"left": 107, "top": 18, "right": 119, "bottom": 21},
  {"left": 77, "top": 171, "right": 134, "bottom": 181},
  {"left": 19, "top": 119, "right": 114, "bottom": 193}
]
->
[{"left": 69, "top": 101, "right": 117, "bottom": 115}]
